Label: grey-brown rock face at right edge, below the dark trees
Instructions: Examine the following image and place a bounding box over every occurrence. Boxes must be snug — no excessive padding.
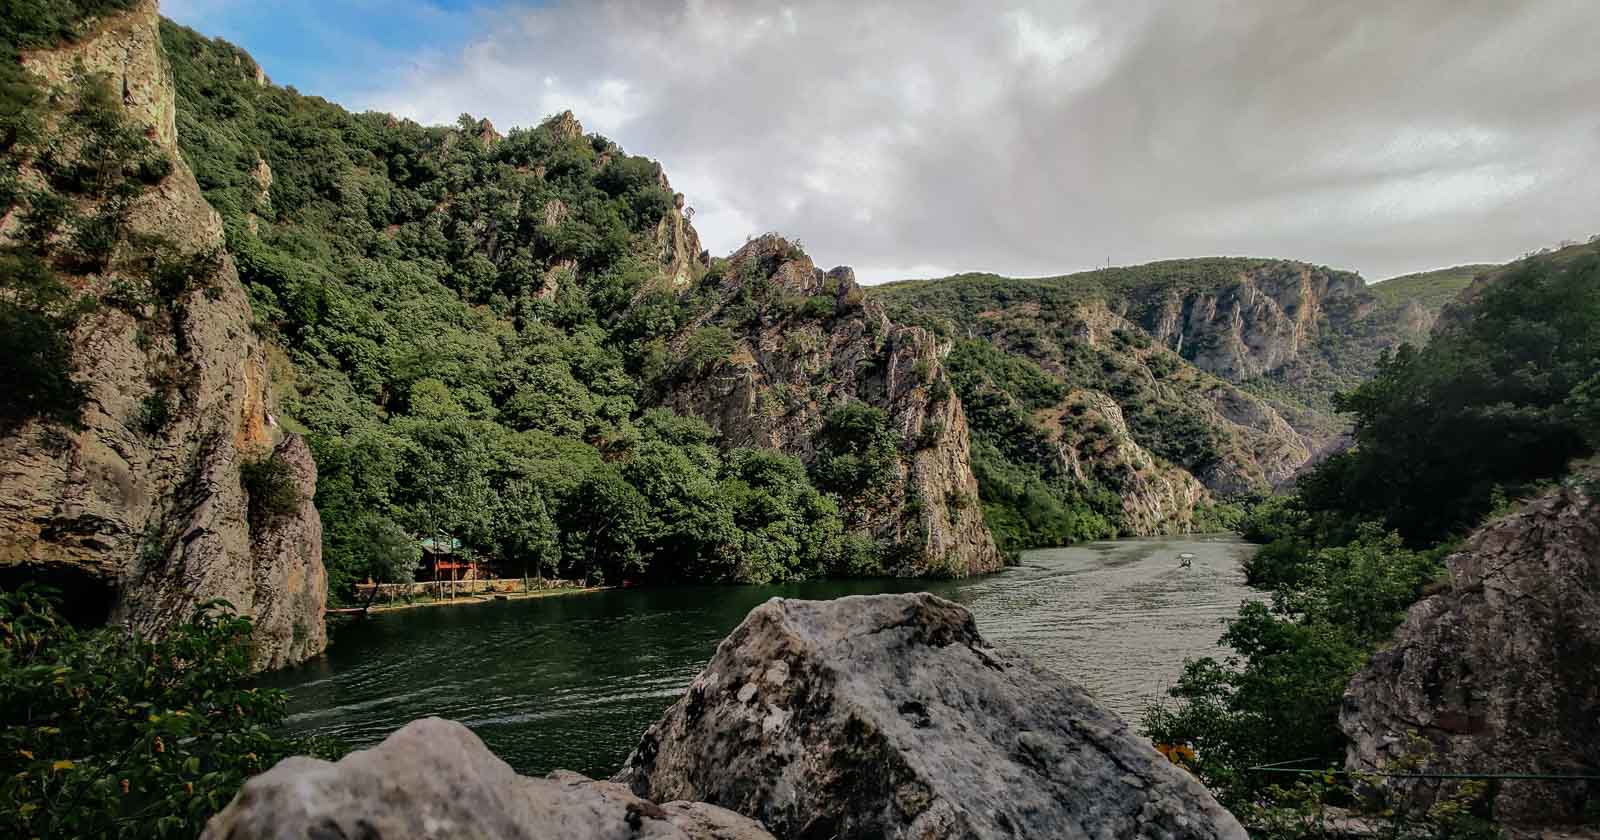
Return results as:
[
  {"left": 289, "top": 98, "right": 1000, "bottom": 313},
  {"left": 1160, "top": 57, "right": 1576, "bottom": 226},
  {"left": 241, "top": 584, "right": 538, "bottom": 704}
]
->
[{"left": 1339, "top": 467, "right": 1600, "bottom": 824}]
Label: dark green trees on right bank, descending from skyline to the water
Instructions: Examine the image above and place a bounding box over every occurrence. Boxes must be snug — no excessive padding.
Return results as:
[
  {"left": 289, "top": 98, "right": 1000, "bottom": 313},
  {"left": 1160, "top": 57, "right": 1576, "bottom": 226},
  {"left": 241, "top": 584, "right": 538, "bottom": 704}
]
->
[{"left": 1144, "top": 248, "right": 1600, "bottom": 837}]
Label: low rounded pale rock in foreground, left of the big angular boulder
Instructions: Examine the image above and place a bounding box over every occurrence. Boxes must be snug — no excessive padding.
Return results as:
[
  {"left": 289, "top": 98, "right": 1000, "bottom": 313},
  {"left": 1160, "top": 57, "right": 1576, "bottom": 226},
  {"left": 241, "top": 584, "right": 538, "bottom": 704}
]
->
[{"left": 202, "top": 718, "right": 771, "bottom": 840}]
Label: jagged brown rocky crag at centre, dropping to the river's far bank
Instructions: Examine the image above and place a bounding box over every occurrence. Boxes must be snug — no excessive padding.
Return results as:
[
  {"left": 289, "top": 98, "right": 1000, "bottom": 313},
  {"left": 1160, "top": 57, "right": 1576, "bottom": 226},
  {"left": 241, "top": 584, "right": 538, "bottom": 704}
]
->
[{"left": 661, "top": 235, "right": 1002, "bottom": 574}]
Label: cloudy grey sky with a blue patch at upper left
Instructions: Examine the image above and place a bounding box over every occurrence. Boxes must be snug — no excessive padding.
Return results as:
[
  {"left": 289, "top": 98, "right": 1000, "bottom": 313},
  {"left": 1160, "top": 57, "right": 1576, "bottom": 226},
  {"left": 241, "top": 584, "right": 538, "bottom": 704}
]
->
[{"left": 162, "top": 0, "right": 1600, "bottom": 282}]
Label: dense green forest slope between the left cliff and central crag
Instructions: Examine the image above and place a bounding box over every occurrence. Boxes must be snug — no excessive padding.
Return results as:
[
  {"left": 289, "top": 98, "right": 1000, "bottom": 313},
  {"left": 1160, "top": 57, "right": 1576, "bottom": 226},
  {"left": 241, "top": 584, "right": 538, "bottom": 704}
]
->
[{"left": 163, "top": 24, "right": 883, "bottom": 598}]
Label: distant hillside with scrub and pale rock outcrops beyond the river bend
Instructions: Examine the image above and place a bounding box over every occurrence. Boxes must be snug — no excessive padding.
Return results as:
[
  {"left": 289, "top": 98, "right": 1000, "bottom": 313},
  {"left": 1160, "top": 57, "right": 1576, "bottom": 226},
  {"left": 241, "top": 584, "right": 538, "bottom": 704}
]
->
[{"left": 870, "top": 258, "right": 1466, "bottom": 547}]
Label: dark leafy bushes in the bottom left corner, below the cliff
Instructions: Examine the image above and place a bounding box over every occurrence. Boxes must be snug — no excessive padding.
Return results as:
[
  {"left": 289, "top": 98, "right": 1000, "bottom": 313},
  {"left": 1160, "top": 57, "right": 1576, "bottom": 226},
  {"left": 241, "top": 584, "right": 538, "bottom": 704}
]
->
[{"left": 0, "top": 589, "right": 328, "bottom": 838}]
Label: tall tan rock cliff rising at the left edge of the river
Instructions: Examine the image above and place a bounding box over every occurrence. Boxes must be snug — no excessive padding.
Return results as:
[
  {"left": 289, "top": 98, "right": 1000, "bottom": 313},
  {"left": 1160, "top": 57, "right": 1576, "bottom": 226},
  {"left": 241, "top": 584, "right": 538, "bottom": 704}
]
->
[{"left": 0, "top": 0, "right": 325, "bottom": 667}]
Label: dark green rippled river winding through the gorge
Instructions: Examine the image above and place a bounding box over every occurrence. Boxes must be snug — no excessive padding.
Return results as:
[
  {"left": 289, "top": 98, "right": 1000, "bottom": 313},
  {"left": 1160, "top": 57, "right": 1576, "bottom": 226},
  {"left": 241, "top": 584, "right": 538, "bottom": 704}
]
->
[{"left": 262, "top": 536, "right": 1253, "bottom": 778}]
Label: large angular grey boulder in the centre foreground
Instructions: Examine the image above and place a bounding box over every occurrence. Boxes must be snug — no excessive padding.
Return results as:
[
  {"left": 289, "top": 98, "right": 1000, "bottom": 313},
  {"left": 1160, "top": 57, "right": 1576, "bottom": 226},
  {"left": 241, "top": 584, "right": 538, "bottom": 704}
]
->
[{"left": 613, "top": 594, "right": 1245, "bottom": 840}]
